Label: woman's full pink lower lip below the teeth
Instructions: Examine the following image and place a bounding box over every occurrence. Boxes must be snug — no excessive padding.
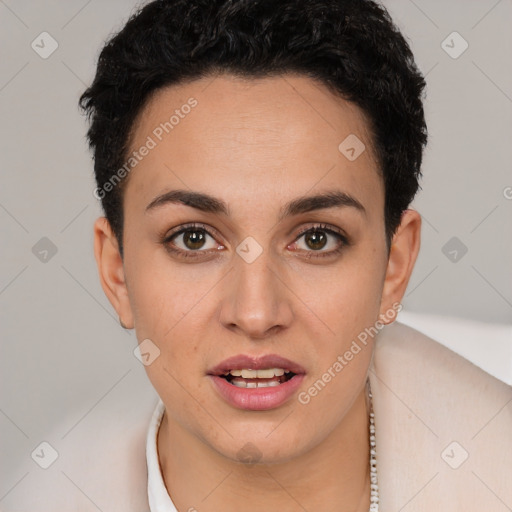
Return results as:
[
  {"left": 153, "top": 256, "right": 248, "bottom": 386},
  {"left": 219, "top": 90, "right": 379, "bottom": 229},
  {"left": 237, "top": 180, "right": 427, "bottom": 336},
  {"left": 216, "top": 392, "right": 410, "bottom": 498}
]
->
[{"left": 208, "top": 373, "right": 304, "bottom": 411}]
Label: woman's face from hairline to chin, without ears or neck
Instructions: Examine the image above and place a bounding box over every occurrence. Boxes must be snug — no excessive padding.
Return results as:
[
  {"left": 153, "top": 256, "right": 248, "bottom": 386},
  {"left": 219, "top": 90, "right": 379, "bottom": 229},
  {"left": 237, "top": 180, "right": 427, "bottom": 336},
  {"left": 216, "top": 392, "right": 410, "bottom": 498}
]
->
[{"left": 97, "top": 75, "right": 411, "bottom": 462}]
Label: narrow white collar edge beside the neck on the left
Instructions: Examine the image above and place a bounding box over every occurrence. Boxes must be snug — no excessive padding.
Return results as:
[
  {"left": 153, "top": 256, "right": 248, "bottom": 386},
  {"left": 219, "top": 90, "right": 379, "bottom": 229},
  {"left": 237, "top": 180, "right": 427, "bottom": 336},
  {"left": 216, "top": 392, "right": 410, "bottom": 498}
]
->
[{"left": 146, "top": 399, "right": 178, "bottom": 512}]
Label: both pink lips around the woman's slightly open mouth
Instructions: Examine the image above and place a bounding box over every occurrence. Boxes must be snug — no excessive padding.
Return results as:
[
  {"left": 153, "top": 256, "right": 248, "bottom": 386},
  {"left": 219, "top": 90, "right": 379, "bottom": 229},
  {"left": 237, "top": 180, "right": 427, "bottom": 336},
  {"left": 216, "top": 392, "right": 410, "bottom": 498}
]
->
[{"left": 208, "top": 354, "right": 306, "bottom": 411}]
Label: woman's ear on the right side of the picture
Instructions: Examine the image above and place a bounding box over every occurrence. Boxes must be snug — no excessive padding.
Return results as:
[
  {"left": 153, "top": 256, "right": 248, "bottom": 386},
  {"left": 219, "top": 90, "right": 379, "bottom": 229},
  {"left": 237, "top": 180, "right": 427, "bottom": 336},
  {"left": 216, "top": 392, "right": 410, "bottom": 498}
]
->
[{"left": 380, "top": 209, "right": 421, "bottom": 324}]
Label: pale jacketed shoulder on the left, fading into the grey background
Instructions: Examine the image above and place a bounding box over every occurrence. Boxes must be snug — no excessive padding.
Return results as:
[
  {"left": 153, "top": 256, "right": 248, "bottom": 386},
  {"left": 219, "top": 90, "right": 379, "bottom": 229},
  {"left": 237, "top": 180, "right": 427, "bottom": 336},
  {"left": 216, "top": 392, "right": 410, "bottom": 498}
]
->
[{"left": 2, "top": 374, "right": 159, "bottom": 512}]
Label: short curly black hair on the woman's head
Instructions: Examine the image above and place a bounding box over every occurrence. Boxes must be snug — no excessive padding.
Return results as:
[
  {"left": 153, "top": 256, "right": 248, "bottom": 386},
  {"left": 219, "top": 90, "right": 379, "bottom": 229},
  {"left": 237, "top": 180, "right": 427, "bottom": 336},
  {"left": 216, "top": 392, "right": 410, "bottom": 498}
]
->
[{"left": 79, "top": 0, "right": 427, "bottom": 255}]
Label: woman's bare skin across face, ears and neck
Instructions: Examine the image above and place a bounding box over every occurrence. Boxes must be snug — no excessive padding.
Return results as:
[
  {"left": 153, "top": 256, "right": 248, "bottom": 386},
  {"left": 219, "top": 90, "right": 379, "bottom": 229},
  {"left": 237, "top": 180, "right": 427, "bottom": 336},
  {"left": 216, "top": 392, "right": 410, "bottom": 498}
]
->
[{"left": 94, "top": 74, "right": 421, "bottom": 512}]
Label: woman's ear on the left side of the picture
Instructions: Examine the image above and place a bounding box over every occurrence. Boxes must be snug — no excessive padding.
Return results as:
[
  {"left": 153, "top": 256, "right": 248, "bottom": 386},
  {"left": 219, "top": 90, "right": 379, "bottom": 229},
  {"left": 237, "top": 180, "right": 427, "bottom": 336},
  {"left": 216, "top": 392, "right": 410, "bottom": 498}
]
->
[{"left": 94, "top": 217, "right": 133, "bottom": 329}]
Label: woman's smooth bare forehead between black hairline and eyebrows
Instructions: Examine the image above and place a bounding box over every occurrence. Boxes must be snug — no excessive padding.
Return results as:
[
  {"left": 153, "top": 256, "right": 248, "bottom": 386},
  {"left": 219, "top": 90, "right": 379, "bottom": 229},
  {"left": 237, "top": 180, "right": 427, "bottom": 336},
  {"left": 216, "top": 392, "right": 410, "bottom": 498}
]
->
[{"left": 122, "top": 71, "right": 384, "bottom": 218}]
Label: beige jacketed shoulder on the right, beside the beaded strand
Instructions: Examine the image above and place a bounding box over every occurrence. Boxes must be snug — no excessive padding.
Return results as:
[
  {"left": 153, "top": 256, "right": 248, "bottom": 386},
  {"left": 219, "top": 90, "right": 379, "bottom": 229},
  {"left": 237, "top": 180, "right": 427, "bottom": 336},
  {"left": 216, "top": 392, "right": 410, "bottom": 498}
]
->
[{"left": 370, "top": 322, "right": 512, "bottom": 512}]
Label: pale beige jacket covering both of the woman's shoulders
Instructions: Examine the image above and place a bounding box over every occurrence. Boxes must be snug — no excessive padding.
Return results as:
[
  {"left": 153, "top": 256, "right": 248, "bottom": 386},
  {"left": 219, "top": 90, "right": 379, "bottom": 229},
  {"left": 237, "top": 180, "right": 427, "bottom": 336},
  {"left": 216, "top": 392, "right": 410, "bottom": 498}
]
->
[{"left": 5, "top": 322, "right": 512, "bottom": 512}]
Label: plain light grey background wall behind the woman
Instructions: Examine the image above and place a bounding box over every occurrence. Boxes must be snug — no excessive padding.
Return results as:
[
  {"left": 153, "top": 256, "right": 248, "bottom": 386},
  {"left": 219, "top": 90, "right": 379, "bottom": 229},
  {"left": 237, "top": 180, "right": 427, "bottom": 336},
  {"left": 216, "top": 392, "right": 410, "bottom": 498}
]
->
[{"left": 0, "top": 0, "right": 512, "bottom": 506}]
